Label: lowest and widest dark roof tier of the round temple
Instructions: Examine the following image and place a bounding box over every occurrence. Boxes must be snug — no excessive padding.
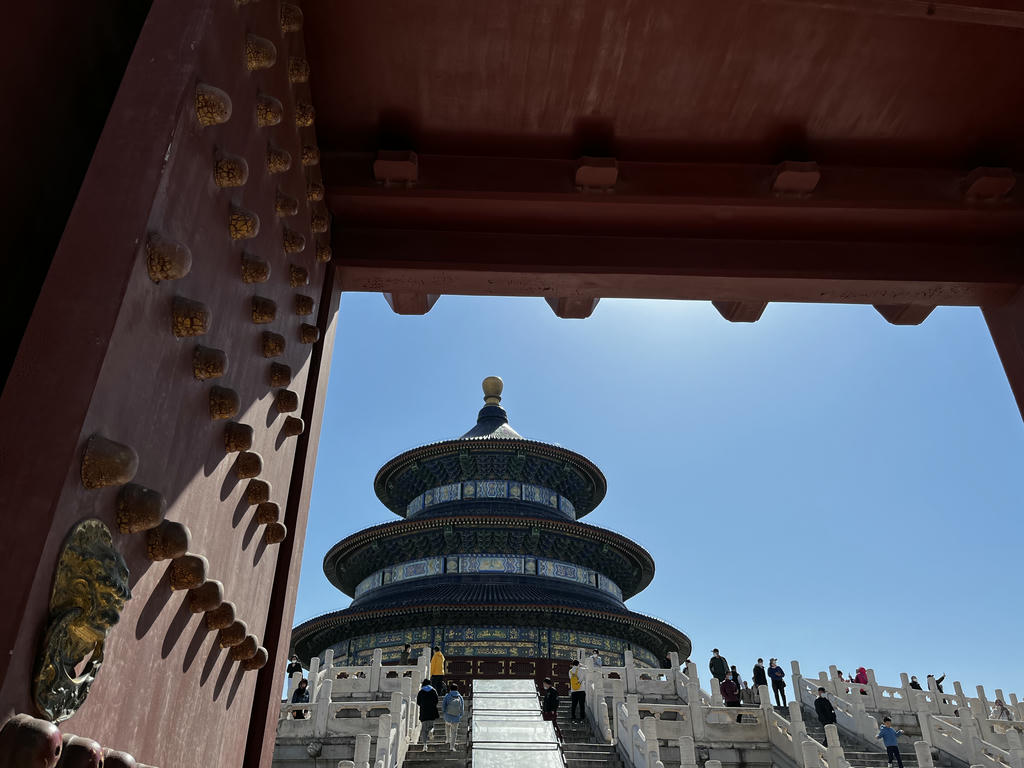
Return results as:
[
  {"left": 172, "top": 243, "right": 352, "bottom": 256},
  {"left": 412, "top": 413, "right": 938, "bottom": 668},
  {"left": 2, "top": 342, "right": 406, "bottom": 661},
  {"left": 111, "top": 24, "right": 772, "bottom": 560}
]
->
[{"left": 292, "top": 580, "right": 691, "bottom": 659}]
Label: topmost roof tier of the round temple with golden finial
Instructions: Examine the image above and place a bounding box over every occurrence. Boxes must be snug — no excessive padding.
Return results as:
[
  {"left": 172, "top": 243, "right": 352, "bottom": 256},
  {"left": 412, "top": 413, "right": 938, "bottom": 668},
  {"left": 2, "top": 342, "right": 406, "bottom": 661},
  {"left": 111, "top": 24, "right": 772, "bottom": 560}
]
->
[{"left": 374, "top": 376, "right": 607, "bottom": 519}]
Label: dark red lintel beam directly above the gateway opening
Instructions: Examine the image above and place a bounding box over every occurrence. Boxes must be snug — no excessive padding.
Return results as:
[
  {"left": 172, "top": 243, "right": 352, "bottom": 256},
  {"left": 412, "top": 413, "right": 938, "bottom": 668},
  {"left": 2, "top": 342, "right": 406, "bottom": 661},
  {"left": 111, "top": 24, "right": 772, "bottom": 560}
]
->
[{"left": 334, "top": 228, "right": 1024, "bottom": 306}]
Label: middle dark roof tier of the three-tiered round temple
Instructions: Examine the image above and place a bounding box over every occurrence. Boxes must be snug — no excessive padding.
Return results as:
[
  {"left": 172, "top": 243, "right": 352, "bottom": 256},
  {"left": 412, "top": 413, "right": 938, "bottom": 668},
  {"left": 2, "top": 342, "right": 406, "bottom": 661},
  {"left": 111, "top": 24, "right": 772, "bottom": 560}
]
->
[{"left": 324, "top": 514, "right": 654, "bottom": 598}]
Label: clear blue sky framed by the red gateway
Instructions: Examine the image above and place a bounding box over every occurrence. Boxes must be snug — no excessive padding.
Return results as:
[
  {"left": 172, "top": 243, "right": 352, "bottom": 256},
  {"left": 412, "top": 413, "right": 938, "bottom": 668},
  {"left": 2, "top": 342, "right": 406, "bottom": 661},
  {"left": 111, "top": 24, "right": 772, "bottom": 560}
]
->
[{"left": 295, "top": 294, "right": 1024, "bottom": 696}]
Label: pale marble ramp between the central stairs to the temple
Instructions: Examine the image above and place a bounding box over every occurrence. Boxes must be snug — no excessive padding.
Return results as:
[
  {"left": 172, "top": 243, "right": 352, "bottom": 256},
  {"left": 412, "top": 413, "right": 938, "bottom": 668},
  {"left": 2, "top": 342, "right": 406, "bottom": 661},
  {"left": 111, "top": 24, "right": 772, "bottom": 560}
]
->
[{"left": 472, "top": 680, "right": 565, "bottom": 768}]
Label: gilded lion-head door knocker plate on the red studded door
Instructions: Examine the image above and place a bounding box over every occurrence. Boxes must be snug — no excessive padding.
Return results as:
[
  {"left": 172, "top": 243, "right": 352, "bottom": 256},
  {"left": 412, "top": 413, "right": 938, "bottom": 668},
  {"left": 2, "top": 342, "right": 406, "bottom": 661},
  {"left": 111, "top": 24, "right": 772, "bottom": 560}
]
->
[{"left": 33, "top": 520, "right": 131, "bottom": 723}]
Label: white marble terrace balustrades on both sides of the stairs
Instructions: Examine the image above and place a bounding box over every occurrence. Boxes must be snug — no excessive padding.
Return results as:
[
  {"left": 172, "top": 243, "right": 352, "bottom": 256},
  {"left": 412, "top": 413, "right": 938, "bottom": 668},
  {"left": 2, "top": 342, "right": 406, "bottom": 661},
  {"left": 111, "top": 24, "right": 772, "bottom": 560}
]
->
[{"left": 278, "top": 649, "right": 1024, "bottom": 768}]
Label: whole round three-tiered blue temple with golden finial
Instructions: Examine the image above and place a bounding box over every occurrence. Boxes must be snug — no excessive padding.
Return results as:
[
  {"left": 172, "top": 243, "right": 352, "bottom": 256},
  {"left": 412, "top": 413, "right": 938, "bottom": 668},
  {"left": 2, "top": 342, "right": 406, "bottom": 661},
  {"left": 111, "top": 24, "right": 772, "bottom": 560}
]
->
[{"left": 292, "top": 377, "right": 690, "bottom": 682}]
